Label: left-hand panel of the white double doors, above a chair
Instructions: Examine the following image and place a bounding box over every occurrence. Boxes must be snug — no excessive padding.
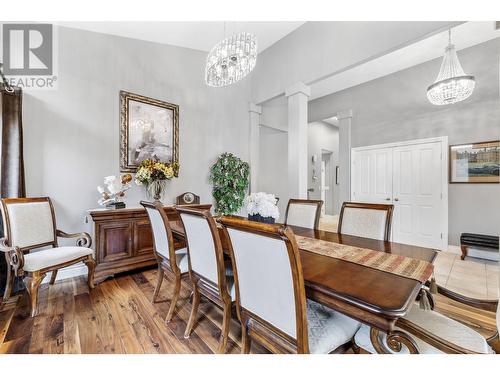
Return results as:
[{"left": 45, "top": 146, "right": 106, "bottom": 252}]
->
[{"left": 351, "top": 147, "right": 392, "bottom": 203}]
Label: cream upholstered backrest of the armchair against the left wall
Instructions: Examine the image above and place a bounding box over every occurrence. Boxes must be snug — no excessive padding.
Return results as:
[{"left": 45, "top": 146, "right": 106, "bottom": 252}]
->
[{"left": 2, "top": 197, "right": 57, "bottom": 251}]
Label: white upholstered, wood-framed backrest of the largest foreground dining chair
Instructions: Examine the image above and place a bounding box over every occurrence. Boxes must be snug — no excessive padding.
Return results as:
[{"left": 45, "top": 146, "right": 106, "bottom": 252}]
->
[{"left": 218, "top": 217, "right": 308, "bottom": 352}]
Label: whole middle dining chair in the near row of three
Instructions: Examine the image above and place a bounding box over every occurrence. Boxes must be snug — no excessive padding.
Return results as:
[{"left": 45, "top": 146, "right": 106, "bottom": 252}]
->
[{"left": 177, "top": 207, "right": 235, "bottom": 353}]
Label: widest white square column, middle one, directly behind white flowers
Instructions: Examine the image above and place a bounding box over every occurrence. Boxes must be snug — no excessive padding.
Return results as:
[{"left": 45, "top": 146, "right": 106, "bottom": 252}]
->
[{"left": 285, "top": 82, "right": 311, "bottom": 199}]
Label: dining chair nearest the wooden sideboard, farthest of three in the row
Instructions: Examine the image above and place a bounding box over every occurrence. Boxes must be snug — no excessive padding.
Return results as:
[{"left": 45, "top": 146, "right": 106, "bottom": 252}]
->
[{"left": 141, "top": 201, "right": 189, "bottom": 323}]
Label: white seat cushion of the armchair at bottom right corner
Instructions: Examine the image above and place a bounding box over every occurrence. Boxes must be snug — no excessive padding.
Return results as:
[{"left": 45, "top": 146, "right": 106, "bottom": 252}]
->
[{"left": 354, "top": 304, "right": 493, "bottom": 354}]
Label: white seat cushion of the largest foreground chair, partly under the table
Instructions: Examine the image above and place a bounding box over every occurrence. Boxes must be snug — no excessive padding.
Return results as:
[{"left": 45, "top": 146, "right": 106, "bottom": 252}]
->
[{"left": 307, "top": 300, "right": 361, "bottom": 354}]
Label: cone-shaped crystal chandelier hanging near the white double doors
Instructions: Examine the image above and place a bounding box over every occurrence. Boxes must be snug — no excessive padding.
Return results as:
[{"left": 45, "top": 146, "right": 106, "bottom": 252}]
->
[{"left": 427, "top": 30, "right": 475, "bottom": 105}]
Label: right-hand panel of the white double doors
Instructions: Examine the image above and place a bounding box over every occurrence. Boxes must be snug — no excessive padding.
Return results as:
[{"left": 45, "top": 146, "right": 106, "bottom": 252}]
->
[{"left": 392, "top": 142, "right": 445, "bottom": 248}]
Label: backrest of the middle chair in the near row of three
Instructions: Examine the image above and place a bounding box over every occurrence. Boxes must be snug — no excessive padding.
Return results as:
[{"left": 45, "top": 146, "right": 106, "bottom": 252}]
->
[{"left": 177, "top": 207, "right": 227, "bottom": 295}]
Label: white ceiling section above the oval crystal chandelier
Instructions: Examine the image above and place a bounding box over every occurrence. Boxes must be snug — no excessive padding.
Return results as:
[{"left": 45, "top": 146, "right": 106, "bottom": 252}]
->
[{"left": 56, "top": 22, "right": 304, "bottom": 53}]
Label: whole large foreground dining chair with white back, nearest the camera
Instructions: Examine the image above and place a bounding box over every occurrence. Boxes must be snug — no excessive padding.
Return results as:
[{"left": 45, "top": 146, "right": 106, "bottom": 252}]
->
[{"left": 218, "top": 217, "right": 360, "bottom": 354}]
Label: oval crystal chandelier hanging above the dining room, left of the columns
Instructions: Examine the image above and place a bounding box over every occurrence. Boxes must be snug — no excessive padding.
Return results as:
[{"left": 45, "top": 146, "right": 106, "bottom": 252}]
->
[{"left": 205, "top": 33, "right": 257, "bottom": 87}]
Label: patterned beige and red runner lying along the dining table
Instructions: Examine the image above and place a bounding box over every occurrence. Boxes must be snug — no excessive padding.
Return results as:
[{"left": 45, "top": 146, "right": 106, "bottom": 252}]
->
[{"left": 295, "top": 235, "right": 434, "bottom": 283}]
